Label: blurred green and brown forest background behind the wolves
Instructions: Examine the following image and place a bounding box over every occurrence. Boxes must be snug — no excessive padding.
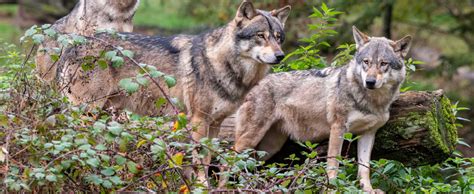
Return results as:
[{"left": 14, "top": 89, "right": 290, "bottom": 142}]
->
[{"left": 0, "top": 0, "right": 474, "bottom": 157}]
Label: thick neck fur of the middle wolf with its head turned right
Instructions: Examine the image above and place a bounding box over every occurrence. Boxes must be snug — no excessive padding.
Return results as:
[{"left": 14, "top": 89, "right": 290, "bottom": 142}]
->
[{"left": 197, "top": 24, "right": 269, "bottom": 101}]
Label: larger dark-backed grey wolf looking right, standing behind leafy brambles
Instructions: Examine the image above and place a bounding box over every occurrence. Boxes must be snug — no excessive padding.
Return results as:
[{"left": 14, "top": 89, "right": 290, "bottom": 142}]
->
[{"left": 58, "top": 1, "right": 291, "bottom": 186}]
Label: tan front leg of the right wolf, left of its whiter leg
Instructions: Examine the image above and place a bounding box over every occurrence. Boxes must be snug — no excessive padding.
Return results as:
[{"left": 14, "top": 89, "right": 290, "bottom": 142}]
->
[{"left": 327, "top": 121, "right": 347, "bottom": 179}]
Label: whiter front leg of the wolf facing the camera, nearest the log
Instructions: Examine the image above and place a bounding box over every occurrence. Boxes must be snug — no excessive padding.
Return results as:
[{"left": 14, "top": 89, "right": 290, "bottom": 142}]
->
[{"left": 357, "top": 130, "right": 381, "bottom": 193}]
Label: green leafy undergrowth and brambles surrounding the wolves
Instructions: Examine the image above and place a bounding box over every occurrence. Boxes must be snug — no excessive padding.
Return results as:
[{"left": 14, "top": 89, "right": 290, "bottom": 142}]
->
[{"left": 0, "top": 5, "right": 474, "bottom": 193}]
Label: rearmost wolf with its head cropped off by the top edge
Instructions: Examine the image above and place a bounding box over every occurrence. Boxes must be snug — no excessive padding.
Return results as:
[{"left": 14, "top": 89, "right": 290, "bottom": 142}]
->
[{"left": 36, "top": 0, "right": 140, "bottom": 82}]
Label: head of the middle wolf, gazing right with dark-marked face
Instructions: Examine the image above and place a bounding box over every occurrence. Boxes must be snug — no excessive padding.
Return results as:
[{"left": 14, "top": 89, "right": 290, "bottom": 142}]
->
[{"left": 234, "top": 1, "right": 291, "bottom": 64}]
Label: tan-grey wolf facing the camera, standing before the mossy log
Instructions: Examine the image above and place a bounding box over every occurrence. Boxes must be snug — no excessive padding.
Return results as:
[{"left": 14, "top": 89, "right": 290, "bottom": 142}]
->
[{"left": 235, "top": 27, "right": 411, "bottom": 192}]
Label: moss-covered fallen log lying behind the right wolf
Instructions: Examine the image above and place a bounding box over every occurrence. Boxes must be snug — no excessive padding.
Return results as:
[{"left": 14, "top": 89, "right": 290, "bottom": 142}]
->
[{"left": 220, "top": 90, "right": 458, "bottom": 166}]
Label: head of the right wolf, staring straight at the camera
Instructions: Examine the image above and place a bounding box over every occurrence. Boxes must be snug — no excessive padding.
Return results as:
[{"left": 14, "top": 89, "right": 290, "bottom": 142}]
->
[{"left": 353, "top": 27, "right": 411, "bottom": 89}]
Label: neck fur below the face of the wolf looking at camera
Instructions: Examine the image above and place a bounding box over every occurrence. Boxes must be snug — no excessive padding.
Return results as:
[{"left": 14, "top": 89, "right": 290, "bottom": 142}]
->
[{"left": 344, "top": 60, "right": 401, "bottom": 112}]
